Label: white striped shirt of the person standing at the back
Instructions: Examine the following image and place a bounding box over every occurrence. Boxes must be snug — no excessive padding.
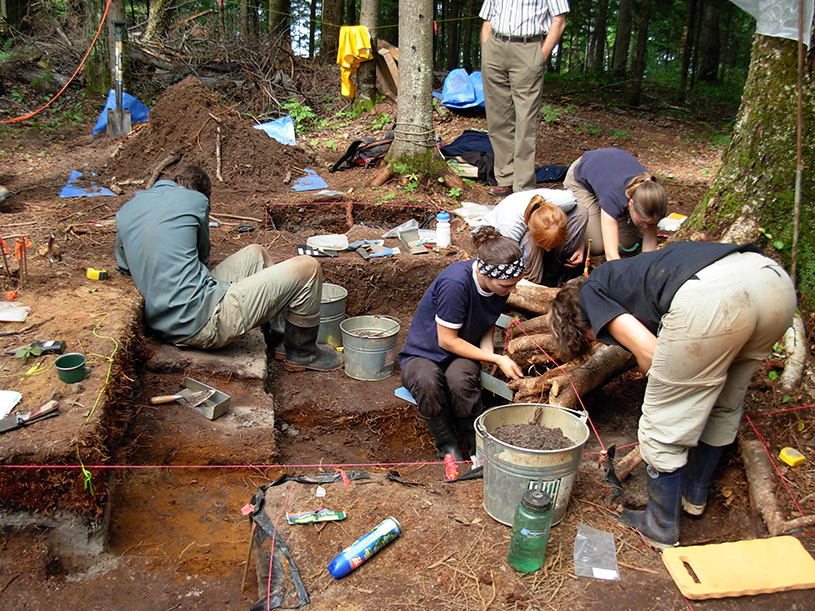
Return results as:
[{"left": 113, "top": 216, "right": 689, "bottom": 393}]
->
[{"left": 478, "top": 0, "right": 569, "bottom": 36}]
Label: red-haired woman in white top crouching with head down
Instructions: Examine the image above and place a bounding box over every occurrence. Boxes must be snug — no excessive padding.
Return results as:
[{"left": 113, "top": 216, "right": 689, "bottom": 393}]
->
[{"left": 475, "top": 189, "right": 589, "bottom": 286}]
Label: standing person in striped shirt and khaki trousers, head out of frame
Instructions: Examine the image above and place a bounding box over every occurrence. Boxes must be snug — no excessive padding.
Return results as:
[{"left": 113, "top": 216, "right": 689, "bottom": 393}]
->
[{"left": 479, "top": 0, "right": 569, "bottom": 197}]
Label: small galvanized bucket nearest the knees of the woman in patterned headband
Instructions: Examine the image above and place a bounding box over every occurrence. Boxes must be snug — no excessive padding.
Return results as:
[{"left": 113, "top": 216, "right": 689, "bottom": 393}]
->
[{"left": 340, "top": 316, "right": 399, "bottom": 380}]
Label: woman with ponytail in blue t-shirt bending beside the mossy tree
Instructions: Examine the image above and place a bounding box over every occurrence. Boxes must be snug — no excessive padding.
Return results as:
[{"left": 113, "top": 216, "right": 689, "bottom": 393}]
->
[{"left": 563, "top": 148, "right": 668, "bottom": 261}]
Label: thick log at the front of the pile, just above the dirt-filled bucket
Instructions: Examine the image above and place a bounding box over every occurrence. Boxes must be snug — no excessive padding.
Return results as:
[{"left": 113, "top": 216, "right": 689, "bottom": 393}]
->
[{"left": 549, "top": 345, "right": 637, "bottom": 409}]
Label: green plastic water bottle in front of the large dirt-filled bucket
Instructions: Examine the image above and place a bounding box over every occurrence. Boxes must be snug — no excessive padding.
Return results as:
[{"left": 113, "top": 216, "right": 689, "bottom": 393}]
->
[{"left": 507, "top": 490, "right": 554, "bottom": 573}]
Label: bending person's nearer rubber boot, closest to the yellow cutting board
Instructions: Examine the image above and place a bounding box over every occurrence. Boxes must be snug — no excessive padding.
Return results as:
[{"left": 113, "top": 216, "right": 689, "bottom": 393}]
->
[{"left": 620, "top": 467, "right": 685, "bottom": 550}]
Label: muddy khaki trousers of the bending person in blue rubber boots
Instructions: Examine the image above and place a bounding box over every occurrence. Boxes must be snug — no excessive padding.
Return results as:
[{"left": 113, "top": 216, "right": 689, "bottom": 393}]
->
[{"left": 639, "top": 252, "right": 796, "bottom": 472}]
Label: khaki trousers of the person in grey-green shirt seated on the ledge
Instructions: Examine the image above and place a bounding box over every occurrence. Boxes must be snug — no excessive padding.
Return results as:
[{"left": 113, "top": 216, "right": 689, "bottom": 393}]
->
[{"left": 179, "top": 244, "right": 323, "bottom": 348}]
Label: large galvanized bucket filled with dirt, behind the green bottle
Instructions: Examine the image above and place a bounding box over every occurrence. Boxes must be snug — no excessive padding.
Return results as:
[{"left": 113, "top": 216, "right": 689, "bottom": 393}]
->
[{"left": 475, "top": 403, "right": 589, "bottom": 526}]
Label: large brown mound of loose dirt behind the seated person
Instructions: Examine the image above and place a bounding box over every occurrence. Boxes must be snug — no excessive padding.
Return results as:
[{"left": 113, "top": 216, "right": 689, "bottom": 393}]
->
[{"left": 97, "top": 76, "right": 314, "bottom": 184}]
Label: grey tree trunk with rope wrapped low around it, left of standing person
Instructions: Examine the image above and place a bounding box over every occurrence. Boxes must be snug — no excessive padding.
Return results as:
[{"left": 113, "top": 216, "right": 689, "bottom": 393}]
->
[{"left": 387, "top": 0, "right": 436, "bottom": 175}]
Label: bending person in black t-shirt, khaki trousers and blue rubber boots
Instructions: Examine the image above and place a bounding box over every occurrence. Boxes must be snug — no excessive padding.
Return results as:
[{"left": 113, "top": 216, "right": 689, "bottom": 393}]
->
[{"left": 548, "top": 242, "right": 796, "bottom": 549}]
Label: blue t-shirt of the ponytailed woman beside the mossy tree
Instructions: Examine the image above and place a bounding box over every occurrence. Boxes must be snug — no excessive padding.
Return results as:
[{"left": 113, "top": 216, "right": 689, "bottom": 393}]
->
[{"left": 574, "top": 148, "right": 648, "bottom": 221}]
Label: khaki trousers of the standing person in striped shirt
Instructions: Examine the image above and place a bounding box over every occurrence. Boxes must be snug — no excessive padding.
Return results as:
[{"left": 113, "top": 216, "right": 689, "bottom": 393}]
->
[{"left": 481, "top": 36, "right": 545, "bottom": 192}]
